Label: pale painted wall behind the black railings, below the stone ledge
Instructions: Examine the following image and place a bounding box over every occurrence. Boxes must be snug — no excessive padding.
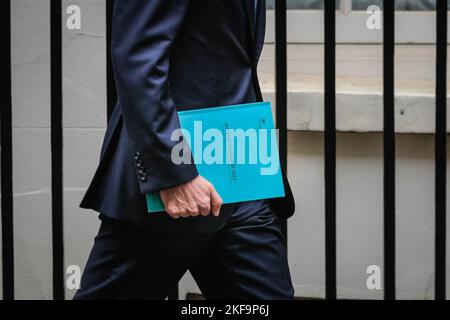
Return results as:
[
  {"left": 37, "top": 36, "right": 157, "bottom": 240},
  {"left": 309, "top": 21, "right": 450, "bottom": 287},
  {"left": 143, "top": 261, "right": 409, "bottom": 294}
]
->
[{"left": 4, "top": 0, "right": 450, "bottom": 299}]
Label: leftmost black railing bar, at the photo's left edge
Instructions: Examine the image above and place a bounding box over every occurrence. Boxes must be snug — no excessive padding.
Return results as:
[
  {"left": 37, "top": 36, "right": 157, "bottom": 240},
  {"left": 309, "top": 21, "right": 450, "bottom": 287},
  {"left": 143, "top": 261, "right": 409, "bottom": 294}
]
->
[{"left": 0, "top": 0, "right": 14, "bottom": 300}]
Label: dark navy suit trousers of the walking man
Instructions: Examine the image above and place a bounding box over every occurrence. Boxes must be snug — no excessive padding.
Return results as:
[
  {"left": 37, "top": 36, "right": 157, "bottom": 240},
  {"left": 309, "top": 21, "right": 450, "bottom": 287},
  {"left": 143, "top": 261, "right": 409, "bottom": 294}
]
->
[{"left": 75, "top": 201, "right": 294, "bottom": 300}]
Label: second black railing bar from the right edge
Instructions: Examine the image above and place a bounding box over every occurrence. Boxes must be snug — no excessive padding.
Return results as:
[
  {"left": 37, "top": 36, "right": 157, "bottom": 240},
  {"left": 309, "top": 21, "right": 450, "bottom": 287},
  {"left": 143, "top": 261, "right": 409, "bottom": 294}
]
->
[{"left": 383, "top": 0, "right": 395, "bottom": 300}]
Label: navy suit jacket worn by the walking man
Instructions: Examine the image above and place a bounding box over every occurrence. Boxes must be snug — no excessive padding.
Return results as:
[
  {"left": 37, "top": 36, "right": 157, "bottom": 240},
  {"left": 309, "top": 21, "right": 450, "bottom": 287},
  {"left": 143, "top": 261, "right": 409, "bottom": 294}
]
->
[{"left": 81, "top": 0, "right": 294, "bottom": 233}]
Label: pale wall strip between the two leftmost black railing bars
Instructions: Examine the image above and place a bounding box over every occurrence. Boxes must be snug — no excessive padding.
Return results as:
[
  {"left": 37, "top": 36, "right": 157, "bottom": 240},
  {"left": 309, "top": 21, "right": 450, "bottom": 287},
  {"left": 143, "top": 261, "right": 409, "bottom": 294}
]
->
[{"left": 12, "top": 0, "right": 52, "bottom": 299}]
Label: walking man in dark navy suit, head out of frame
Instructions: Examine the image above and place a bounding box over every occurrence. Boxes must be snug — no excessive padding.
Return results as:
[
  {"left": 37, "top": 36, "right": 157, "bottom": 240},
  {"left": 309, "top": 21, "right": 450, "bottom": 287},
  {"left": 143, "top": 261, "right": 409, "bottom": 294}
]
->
[{"left": 75, "top": 0, "right": 294, "bottom": 299}]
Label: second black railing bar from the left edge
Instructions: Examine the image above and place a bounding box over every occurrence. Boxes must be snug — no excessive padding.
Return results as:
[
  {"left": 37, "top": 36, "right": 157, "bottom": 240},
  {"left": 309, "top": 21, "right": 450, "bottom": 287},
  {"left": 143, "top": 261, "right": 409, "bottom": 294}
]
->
[{"left": 50, "top": 0, "right": 64, "bottom": 300}]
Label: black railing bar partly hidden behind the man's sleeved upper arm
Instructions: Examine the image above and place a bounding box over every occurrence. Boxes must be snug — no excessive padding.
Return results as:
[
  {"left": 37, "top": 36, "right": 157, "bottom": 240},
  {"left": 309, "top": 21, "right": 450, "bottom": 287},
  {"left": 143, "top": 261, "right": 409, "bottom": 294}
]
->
[{"left": 106, "top": 0, "right": 117, "bottom": 120}]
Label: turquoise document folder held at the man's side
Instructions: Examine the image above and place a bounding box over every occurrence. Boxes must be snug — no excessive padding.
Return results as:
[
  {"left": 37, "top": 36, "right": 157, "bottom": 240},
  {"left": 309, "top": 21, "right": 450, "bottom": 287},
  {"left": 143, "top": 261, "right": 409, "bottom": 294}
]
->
[{"left": 146, "top": 102, "right": 285, "bottom": 212}]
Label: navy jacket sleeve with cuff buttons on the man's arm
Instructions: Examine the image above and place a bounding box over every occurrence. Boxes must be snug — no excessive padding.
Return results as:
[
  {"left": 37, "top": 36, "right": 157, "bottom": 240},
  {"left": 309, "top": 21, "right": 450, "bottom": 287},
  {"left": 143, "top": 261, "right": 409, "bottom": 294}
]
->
[{"left": 112, "top": 0, "right": 198, "bottom": 194}]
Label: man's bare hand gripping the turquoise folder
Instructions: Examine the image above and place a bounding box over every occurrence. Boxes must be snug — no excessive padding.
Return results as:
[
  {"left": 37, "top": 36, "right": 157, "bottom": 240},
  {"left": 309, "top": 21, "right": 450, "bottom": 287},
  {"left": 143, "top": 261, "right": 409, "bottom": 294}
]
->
[{"left": 160, "top": 176, "right": 223, "bottom": 219}]
